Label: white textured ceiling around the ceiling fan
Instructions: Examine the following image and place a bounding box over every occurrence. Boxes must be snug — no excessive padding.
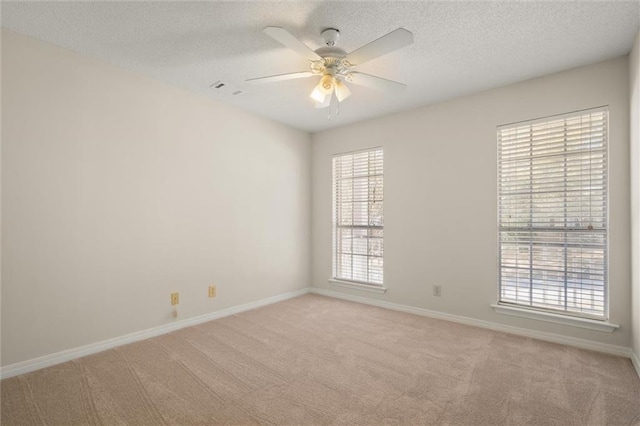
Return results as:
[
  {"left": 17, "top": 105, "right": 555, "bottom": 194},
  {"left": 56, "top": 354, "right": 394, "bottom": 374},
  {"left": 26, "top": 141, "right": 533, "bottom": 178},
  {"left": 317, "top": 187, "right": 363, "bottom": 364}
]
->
[{"left": 1, "top": 0, "right": 640, "bottom": 132}]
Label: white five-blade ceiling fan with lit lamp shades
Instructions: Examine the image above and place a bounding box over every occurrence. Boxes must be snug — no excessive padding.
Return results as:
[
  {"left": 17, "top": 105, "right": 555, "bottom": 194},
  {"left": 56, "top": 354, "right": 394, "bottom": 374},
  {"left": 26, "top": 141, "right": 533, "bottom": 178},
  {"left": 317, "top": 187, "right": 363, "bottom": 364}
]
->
[{"left": 246, "top": 27, "right": 413, "bottom": 108}]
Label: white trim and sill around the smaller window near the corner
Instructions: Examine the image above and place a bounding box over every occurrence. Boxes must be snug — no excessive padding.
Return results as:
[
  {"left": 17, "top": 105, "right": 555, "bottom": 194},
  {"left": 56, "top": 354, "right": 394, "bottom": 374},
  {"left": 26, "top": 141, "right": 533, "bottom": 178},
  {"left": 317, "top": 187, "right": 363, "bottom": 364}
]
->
[{"left": 329, "top": 146, "right": 387, "bottom": 293}]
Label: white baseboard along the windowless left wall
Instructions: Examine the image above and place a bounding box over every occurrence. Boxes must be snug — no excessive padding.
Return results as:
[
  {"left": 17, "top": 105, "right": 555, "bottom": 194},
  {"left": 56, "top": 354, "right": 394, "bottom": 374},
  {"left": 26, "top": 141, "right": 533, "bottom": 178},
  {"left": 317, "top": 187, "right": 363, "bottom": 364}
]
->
[{"left": 0, "top": 287, "right": 310, "bottom": 379}]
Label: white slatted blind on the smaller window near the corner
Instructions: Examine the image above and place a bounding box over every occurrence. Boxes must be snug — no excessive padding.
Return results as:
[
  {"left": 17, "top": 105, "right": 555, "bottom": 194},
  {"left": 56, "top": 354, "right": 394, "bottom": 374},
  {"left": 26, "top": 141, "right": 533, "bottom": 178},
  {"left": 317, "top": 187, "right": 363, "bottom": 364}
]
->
[{"left": 333, "top": 148, "right": 384, "bottom": 286}]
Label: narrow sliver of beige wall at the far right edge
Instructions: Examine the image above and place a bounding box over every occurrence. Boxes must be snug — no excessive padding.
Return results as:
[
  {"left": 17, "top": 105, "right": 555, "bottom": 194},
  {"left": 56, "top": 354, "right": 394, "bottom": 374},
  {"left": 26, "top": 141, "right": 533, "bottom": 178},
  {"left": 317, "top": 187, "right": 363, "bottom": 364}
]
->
[{"left": 629, "top": 32, "right": 640, "bottom": 366}]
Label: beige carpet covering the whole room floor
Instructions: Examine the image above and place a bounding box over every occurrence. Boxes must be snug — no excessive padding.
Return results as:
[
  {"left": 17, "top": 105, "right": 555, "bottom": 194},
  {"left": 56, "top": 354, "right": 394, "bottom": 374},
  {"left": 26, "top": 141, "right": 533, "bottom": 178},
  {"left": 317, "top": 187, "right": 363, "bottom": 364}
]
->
[{"left": 0, "top": 295, "right": 640, "bottom": 426}]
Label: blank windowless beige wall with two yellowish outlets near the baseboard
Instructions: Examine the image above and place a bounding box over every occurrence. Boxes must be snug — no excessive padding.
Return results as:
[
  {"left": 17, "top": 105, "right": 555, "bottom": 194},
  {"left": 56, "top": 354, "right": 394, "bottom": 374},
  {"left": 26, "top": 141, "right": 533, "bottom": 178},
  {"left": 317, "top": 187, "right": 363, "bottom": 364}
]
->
[{"left": 2, "top": 31, "right": 311, "bottom": 365}]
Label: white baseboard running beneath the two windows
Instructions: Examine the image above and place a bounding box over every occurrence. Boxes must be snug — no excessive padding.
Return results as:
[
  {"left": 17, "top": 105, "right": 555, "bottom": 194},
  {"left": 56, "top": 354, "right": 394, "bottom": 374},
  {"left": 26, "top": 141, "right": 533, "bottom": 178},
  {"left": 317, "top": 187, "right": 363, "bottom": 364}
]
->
[{"left": 311, "top": 287, "right": 640, "bottom": 360}]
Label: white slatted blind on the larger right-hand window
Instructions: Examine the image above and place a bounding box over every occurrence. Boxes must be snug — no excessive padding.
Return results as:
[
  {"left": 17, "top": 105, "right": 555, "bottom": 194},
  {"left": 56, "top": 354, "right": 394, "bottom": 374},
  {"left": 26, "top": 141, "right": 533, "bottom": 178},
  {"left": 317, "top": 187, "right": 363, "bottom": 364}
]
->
[{"left": 498, "top": 108, "right": 608, "bottom": 319}]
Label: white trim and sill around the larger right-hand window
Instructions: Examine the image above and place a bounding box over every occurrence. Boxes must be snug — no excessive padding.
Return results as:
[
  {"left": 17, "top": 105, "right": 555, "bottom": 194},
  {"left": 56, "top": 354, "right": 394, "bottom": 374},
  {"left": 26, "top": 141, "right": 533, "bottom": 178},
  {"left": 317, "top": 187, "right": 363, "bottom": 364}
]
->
[{"left": 491, "top": 105, "right": 608, "bottom": 320}]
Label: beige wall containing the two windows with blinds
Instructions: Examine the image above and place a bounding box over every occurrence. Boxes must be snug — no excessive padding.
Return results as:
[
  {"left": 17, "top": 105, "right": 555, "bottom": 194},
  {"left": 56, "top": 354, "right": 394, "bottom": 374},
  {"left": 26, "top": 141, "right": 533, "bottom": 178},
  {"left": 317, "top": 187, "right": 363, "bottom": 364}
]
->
[{"left": 312, "top": 57, "right": 631, "bottom": 347}]
